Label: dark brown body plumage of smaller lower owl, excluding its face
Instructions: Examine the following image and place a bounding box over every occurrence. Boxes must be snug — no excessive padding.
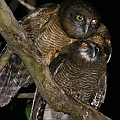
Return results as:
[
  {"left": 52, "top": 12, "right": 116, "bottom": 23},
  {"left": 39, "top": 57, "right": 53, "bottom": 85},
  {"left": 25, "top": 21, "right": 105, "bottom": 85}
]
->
[{"left": 49, "top": 40, "right": 106, "bottom": 109}]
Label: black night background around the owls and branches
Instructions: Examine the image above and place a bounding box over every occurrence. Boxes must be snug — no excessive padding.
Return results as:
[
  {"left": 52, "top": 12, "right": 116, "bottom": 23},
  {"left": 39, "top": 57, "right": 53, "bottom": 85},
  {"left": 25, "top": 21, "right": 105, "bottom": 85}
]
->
[{"left": 0, "top": 0, "right": 120, "bottom": 120}]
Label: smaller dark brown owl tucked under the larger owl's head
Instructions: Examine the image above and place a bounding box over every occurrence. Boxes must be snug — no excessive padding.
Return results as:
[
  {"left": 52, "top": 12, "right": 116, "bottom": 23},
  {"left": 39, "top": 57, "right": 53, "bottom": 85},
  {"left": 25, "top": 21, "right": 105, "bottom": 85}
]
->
[{"left": 49, "top": 40, "right": 107, "bottom": 109}]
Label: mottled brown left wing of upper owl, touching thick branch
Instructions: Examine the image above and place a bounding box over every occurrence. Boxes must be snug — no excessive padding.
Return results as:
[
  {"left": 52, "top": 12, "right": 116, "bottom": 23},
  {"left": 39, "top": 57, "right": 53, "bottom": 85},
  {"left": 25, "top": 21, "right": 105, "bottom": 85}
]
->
[{"left": 19, "top": 3, "right": 57, "bottom": 41}]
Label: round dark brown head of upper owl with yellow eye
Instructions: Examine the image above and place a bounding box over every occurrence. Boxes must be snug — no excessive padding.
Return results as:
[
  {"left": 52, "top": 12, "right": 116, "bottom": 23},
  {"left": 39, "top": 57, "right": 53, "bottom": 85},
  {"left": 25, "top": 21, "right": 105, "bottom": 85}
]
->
[{"left": 59, "top": 0, "right": 100, "bottom": 38}]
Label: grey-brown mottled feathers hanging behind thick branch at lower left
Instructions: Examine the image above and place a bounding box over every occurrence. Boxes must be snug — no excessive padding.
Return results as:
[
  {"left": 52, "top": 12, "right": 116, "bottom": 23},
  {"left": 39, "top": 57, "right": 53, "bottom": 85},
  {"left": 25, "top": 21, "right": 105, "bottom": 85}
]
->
[{"left": 0, "top": 54, "right": 33, "bottom": 107}]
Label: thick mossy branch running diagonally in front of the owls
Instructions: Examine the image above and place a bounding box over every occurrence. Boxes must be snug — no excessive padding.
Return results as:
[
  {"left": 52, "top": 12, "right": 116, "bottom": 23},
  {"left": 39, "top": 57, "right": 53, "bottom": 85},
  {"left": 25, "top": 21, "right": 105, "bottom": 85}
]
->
[{"left": 0, "top": 0, "right": 110, "bottom": 120}]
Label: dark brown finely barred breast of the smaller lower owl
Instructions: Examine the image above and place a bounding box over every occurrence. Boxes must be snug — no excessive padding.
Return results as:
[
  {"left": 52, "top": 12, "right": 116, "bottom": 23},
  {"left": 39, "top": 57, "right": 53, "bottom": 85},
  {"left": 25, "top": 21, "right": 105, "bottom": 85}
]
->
[{"left": 53, "top": 59, "right": 106, "bottom": 102}]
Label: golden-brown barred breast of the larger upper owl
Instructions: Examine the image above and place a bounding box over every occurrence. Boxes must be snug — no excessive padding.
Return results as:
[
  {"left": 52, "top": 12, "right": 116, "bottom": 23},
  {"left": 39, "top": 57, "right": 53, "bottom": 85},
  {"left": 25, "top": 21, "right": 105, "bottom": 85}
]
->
[{"left": 36, "top": 17, "right": 72, "bottom": 63}]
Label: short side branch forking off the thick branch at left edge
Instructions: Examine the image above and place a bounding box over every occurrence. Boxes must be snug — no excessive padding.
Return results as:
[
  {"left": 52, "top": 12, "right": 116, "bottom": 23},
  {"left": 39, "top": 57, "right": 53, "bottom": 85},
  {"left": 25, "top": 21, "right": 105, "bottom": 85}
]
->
[{"left": 0, "top": 46, "right": 13, "bottom": 70}]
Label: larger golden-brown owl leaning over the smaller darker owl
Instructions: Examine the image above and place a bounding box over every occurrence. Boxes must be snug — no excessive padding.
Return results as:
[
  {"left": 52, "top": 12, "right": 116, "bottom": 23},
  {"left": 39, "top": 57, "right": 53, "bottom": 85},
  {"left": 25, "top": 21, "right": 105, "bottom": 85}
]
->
[{"left": 0, "top": 0, "right": 111, "bottom": 119}]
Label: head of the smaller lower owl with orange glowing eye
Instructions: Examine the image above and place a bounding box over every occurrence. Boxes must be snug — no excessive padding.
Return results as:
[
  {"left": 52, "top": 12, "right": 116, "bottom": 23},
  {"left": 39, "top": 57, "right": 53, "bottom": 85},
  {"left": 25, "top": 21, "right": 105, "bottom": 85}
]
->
[{"left": 69, "top": 40, "right": 100, "bottom": 61}]
